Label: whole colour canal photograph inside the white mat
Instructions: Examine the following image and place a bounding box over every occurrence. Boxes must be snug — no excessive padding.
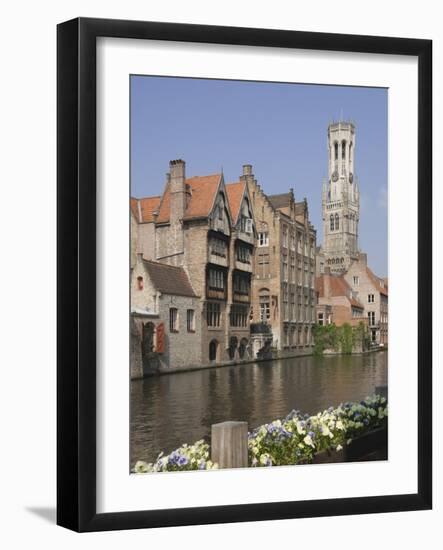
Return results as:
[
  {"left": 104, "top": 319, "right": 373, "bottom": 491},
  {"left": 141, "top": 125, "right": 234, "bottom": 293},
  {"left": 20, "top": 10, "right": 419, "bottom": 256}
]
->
[{"left": 129, "top": 75, "right": 389, "bottom": 474}]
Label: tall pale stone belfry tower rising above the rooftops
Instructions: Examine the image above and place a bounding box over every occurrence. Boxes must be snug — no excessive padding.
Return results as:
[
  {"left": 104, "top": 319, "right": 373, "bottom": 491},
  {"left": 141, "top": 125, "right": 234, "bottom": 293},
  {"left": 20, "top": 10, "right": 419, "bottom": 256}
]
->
[{"left": 321, "top": 121, "right": 360, "bottom": 273}]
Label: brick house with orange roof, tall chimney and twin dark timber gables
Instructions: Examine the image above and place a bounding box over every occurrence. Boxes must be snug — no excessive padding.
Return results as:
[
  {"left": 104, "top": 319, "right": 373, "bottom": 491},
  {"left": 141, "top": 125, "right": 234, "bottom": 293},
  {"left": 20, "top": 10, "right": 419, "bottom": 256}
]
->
[{"left": 131, "top": 160, "right": 255, "bottom": 367}]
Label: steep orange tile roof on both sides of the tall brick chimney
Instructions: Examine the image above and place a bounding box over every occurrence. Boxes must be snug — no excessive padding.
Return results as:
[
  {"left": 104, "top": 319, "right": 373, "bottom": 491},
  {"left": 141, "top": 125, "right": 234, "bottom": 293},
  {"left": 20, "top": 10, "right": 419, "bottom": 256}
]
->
[{"left": 157, "top": 174, "right": 221, "bottom": 223}]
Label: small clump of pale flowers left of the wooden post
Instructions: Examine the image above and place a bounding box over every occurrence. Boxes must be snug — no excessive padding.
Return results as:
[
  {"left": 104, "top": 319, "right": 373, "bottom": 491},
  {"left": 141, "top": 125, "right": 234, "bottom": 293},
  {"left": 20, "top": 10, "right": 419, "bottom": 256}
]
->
[{"left": 133, "top": 440, "right": 217, "bottom": 474}]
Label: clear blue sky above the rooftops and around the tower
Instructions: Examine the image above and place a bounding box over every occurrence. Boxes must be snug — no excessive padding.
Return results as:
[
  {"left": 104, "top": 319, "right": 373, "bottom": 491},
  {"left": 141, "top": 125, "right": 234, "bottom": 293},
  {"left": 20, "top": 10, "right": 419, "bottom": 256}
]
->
[{"left": 131, "top": 76, "right": 388, "bottom": 276}]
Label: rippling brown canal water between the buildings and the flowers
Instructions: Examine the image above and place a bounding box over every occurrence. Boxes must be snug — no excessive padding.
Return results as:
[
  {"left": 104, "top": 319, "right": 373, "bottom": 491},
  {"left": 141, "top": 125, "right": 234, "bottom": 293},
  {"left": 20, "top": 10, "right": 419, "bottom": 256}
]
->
[{"left": 131, "top": 351, "right": 387, "bottom": 465}]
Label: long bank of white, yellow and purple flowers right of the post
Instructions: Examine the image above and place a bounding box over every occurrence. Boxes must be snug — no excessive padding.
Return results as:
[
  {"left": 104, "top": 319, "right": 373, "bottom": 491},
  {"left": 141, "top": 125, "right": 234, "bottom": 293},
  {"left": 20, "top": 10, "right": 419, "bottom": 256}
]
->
[{"left": 248, "top": 395, "right": 387, "bottom": 466}]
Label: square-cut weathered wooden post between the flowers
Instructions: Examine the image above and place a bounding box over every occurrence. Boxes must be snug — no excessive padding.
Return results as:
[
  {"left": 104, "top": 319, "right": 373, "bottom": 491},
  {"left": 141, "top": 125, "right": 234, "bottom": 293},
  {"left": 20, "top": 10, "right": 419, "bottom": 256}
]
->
[{"left": 211, "top": 421, "right": 248, "bottom": 468}]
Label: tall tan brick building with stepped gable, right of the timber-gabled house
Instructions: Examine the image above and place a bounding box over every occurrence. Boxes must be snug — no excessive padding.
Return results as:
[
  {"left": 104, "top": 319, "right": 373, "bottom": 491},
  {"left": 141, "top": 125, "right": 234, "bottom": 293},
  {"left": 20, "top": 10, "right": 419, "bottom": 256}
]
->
[{"left": 245, "top": 165, "right": 316, "bottom": 356}]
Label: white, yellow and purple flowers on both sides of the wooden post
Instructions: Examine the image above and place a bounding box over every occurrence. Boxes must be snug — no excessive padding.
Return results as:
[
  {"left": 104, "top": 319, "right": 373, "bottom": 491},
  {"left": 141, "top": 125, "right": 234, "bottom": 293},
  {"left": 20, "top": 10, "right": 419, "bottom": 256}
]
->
[{"left": 133, "top": 395, "right": 388, "bottom": 473}]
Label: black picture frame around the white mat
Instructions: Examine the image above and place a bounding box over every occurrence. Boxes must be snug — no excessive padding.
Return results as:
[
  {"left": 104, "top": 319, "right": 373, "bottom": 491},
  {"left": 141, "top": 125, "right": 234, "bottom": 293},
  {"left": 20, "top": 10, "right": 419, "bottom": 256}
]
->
[{"left": 57, "top": 18, "right": 432, "bottom": 531}]
